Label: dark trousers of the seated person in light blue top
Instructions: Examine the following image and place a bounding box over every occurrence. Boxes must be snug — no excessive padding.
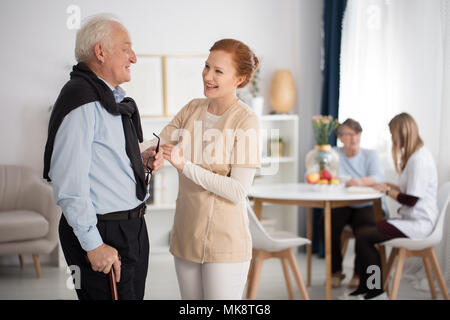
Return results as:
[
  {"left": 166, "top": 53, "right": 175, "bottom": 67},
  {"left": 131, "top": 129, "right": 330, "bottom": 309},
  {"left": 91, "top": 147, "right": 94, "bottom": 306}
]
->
[{"left": 319, "top": 206, "right": 375, "bottom": 274}]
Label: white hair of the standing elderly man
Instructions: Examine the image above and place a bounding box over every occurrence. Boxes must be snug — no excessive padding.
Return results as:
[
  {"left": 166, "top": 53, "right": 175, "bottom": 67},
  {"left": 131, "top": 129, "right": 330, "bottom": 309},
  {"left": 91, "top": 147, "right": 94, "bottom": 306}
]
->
[{"left": 75, "top": 14, "right": 123, "bottom": 62}]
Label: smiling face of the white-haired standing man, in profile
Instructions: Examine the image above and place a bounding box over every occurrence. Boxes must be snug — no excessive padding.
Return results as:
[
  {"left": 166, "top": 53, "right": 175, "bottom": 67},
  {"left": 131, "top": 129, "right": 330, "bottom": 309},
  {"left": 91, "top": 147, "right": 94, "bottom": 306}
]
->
[{"left": 104, "top": 25, "right": 136, "bottom": 87}]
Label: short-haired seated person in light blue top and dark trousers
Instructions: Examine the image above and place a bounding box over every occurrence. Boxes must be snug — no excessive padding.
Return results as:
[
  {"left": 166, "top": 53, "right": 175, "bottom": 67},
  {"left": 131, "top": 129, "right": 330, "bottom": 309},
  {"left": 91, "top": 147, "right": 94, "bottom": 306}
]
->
[{"left": 319, "top": 119, "right": 386, "bottom": 288}]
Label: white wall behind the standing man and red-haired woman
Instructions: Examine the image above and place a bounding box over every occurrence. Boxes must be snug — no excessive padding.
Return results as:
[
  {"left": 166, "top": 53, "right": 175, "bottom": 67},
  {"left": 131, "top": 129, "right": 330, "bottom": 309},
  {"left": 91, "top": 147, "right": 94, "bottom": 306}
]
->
[{"left": 0, "top": 0, "right": 322, "bottom": 264}]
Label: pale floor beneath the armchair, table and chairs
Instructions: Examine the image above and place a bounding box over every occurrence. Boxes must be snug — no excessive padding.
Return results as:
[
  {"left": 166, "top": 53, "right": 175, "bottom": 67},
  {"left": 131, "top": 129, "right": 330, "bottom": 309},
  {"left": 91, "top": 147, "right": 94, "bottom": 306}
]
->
[{"left": 0, "top": 245, "right": 441, "bottom": 300}]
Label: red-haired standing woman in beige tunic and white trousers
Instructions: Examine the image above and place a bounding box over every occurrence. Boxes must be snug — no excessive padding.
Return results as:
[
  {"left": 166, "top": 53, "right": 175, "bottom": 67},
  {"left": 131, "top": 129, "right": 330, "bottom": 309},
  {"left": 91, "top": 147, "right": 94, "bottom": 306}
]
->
[{"left": 161, "top": 39, "right": 260, "bottom": 299}]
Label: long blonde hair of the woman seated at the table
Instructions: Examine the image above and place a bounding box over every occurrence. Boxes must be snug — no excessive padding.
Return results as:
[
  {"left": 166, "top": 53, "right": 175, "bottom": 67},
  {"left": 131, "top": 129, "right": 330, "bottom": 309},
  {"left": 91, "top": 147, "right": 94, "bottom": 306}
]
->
[{"left": 389, "top": 112, "right": 423, "bottom": 173}]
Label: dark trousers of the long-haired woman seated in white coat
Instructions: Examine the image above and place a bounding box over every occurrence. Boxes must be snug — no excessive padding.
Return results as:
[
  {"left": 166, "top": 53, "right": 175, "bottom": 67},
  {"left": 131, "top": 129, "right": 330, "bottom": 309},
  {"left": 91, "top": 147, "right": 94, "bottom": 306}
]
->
[{"left": 355, "top": 220, "right": 407, "bottom": 293}]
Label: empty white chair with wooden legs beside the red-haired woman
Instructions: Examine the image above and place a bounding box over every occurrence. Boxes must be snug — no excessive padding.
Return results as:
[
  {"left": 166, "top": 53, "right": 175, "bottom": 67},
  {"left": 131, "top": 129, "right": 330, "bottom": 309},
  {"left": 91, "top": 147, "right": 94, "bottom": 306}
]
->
[{"left": 247, "top": 200, "right": 310, "bottom": 300}]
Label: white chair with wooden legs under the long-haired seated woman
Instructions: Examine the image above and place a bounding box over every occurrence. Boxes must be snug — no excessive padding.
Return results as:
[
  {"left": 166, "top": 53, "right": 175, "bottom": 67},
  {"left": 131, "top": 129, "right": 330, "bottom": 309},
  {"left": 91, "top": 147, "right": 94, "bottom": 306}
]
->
[{"left": 380, "top": 182, "right": 450, "bottom": 300}]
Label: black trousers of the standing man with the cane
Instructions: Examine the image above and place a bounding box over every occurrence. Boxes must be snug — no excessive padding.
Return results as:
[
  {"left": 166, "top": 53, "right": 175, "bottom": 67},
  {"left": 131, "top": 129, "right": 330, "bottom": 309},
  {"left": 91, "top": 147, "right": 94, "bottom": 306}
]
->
[{"left": 59, "top": 215, "right": 150, "bottom": 300}]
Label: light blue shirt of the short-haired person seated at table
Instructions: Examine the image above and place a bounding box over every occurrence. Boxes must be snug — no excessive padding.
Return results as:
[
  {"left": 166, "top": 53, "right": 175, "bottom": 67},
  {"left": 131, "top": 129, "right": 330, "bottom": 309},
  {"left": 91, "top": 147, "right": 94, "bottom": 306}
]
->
[{"left": 334, "top": 147, "right": 388, "bottom": 214}]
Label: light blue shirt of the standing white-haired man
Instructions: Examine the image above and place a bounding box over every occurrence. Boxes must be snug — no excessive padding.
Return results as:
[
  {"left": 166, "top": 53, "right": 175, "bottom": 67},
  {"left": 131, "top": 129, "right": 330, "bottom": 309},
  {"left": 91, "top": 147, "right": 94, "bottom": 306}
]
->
[{"left": 49, "top": 79, "right": 148, "bottom": 251}]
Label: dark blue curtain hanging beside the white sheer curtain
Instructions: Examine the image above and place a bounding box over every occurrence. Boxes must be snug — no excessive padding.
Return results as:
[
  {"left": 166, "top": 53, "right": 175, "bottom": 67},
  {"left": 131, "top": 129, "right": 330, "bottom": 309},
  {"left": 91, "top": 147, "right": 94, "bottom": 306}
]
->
[{"left": 313, "top": 0, "right": 347, "bottom": 257}]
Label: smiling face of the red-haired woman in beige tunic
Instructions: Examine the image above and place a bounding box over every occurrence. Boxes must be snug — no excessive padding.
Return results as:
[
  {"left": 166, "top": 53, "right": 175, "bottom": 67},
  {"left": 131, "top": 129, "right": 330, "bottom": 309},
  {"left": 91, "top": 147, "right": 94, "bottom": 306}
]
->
[{"left": 202, "top": 50, "right": 245, "bottom": 98}]
